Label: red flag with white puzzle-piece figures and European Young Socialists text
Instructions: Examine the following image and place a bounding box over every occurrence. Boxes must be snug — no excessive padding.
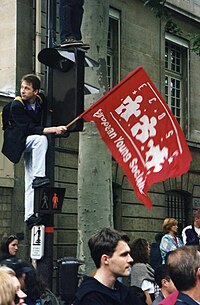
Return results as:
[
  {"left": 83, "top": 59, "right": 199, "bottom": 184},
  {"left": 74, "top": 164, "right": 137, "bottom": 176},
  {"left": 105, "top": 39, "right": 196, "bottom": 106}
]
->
[{"left": 81, "top": 67, "right": 192, "bottom": 207}]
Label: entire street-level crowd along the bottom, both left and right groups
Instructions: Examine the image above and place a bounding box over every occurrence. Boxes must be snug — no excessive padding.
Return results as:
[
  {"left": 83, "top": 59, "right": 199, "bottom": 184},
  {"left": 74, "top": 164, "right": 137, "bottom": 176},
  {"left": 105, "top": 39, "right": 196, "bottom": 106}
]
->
[{"left": 0, "top": 210, "right": 200, "bottom": 305}]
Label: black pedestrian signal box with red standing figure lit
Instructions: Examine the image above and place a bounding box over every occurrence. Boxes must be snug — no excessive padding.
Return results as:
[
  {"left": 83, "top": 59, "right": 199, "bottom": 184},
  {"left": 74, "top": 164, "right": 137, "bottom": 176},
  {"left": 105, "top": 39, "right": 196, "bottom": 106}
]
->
[{"left": 34, "top": 187, "right": 65, "bottom": 214}]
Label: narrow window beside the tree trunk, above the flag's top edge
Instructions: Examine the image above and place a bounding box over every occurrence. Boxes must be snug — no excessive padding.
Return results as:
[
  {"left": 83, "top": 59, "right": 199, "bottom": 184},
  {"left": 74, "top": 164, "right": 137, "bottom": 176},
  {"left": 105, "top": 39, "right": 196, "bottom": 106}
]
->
[{"left": 107, "top": 8, "right": 120, "bottom": 89}]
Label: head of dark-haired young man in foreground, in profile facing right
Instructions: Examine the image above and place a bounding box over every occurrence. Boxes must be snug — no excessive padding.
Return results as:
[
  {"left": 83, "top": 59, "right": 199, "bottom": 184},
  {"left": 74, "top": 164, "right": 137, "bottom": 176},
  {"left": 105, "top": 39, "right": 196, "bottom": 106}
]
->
[{"left": 88, "top": 228, "right": 133, "bottom": 278}]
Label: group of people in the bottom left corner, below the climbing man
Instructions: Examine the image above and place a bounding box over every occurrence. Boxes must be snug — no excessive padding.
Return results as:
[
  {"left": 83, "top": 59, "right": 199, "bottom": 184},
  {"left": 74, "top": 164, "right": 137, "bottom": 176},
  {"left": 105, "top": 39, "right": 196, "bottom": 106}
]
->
[{"left": 0, "top": 235, "right": 59, "bottom": 305}]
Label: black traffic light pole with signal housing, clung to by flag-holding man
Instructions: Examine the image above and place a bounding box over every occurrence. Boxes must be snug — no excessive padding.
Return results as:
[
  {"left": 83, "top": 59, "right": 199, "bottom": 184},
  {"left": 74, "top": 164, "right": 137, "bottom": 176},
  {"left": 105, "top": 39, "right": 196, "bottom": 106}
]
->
[{"left": 37, "top": 0, "right": 98, "bottom": 288}]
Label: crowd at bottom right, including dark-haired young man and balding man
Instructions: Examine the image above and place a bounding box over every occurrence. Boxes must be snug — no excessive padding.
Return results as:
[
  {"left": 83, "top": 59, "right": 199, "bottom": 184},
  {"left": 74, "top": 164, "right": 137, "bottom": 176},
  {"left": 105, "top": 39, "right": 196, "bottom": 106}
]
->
[{"left": 72, "top": 217, "right": 200, "bottom": 305}]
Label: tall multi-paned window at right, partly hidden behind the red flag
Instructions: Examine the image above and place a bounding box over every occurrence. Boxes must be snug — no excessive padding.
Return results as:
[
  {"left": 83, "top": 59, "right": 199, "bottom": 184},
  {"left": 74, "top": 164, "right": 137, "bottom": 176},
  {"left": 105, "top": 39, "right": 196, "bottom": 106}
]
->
[{"left": 165, "top": 34, "right": 188, "bottom": 132}]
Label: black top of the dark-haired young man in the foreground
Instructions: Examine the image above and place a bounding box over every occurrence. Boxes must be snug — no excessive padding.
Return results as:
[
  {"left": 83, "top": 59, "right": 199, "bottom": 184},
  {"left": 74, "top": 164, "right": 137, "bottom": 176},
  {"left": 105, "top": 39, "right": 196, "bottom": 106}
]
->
[{"left": 73, "top": 277, "right": 145, "bottom": 305}]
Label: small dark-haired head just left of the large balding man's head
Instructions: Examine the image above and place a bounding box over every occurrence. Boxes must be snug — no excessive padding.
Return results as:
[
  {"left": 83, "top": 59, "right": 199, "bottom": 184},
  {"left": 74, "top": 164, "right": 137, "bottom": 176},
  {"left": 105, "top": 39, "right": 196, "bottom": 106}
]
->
[{"left": 155, "top": 264, "right": 176, "bottom": 297}]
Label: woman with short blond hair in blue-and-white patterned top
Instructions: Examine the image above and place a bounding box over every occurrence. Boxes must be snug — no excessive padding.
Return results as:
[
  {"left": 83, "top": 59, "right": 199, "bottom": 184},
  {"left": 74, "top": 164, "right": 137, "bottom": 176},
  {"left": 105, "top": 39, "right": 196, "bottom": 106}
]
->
[{"left": 160, "top": 218, "right": 183, "bottom": 264}]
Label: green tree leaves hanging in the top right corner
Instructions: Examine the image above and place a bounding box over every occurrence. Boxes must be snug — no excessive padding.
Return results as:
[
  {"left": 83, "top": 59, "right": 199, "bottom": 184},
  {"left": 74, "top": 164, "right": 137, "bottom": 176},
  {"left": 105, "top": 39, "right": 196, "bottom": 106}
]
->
[{"left": 142, "top": 0, "right": 200, "bottom": 56}]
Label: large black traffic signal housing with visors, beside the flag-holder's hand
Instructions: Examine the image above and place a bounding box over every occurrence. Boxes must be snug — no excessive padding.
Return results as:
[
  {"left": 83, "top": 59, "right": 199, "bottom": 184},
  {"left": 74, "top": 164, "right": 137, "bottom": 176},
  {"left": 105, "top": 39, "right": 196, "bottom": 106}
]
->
[{"left": 38, "top": 47, "right": 98, "bottom": 132}]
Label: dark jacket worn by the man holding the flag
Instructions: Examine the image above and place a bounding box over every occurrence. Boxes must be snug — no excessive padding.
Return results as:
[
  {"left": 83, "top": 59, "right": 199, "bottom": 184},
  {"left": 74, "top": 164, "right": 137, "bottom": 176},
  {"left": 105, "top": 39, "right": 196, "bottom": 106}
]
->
[{"left": 2, "top": 96, "right": 44, "bottom": 163}]
